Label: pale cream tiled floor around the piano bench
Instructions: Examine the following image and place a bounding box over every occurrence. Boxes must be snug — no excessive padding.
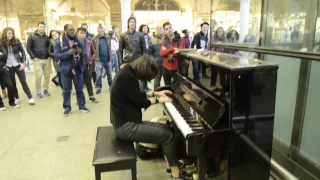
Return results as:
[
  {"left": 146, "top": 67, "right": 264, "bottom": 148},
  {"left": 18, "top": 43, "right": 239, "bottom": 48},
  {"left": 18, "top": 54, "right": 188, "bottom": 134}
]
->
[{"left": 0, "top": 73, "right": 170, "bottom": 180}]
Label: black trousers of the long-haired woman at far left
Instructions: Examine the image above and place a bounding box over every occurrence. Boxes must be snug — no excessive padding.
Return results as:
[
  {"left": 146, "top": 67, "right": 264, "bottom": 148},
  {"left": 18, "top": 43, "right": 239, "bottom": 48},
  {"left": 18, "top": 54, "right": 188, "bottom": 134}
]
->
[{"left": 9, "top": 65, "right": 32, "bottom": 99}]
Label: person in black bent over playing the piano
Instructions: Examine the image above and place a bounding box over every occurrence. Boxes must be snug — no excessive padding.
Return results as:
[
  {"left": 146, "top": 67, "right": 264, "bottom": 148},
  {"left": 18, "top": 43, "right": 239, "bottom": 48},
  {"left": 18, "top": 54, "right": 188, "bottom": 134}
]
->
[{"left": 110, "top": 55, "right": 181, "bottom": 180}]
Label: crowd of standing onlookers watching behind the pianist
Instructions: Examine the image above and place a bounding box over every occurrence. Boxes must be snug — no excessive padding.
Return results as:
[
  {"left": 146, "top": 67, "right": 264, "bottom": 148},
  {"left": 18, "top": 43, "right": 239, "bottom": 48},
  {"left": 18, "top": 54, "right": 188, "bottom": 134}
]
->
[{"left": 0, "top": 14, "right": 248, "bottom": 116}]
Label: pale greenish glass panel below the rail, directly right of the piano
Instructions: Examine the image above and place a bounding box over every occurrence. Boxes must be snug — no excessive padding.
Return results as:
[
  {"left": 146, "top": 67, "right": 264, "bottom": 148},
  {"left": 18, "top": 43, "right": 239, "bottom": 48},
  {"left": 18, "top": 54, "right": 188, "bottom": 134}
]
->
[{"left": 264, "top": 55, "right": 301, "bottom": 146}]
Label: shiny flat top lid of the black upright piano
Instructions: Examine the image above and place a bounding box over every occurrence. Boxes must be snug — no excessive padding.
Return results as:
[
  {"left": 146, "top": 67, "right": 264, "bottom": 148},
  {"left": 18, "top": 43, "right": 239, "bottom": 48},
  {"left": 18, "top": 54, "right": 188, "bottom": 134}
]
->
[{"left": 179, "top": 49, "right": 278, "bottom": 71}]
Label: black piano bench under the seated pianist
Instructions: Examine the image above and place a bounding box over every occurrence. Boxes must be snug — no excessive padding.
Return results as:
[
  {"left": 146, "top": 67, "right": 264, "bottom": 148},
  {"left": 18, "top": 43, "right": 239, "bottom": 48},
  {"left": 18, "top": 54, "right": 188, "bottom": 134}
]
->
[{"left": 92, "top": 127, "right": 137, "bottom": 180}]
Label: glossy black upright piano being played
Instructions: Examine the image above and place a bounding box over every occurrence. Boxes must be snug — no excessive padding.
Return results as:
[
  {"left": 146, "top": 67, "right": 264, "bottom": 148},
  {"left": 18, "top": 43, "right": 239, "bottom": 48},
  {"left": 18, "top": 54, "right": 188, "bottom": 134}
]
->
[{"left": 162, "top": 50, "right": 278, "bottom": 180}]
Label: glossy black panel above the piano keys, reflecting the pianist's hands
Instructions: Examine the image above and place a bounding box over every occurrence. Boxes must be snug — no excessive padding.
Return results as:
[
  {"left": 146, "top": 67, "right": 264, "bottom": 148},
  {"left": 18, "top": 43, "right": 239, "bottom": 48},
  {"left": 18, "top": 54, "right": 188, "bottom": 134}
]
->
[{"left": 171, "top": 73, "right": 226, "bottom": 129}]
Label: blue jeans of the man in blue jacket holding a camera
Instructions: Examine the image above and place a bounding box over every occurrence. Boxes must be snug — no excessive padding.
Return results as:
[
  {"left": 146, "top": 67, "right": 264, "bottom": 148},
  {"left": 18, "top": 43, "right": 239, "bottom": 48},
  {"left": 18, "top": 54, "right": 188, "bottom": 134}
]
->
[{"left": 61, "top": 70, "right": 86, "bottom": 111}]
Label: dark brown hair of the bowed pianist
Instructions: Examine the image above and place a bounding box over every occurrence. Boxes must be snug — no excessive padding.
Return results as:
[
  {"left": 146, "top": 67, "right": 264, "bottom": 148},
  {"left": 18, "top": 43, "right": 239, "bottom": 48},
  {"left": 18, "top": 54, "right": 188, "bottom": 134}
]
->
[{"left": 130, "top": 55, "right": 159, "bottom": 81}]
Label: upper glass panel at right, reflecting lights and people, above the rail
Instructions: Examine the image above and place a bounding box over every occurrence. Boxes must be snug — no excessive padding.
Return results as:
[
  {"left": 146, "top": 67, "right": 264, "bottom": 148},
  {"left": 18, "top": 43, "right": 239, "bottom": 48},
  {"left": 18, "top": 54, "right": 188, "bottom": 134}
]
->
[{"left": 265, "top": 0, "right": 311, "bottom": 50}]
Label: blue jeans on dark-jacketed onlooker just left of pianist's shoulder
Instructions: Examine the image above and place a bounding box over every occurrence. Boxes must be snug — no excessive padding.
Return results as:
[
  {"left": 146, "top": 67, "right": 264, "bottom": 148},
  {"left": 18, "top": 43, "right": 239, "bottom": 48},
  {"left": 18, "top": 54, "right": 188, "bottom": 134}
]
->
[{"left": 96, "top": 61, "right": 112, "bottom": 89}]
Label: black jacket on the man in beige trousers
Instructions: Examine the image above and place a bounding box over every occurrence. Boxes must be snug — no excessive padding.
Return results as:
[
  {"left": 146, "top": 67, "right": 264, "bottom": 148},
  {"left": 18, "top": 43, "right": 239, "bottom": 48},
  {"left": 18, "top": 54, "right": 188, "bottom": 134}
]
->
[{"left": 27, "top": 31, "right": 50, "bottom": 59}]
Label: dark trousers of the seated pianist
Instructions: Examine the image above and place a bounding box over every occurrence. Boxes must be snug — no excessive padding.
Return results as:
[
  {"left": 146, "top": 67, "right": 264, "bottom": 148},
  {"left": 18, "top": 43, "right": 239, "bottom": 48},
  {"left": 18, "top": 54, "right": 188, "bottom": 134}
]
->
[{"left": 115, "top": 121, "right": 178, "bottom": 167}]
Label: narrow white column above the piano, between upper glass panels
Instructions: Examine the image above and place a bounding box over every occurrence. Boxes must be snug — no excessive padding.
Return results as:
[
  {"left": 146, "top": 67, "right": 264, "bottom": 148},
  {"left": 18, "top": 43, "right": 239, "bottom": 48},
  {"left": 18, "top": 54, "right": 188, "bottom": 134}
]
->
[{"left": 239, "top": 0, "right": 250, "bottom": 43}]
